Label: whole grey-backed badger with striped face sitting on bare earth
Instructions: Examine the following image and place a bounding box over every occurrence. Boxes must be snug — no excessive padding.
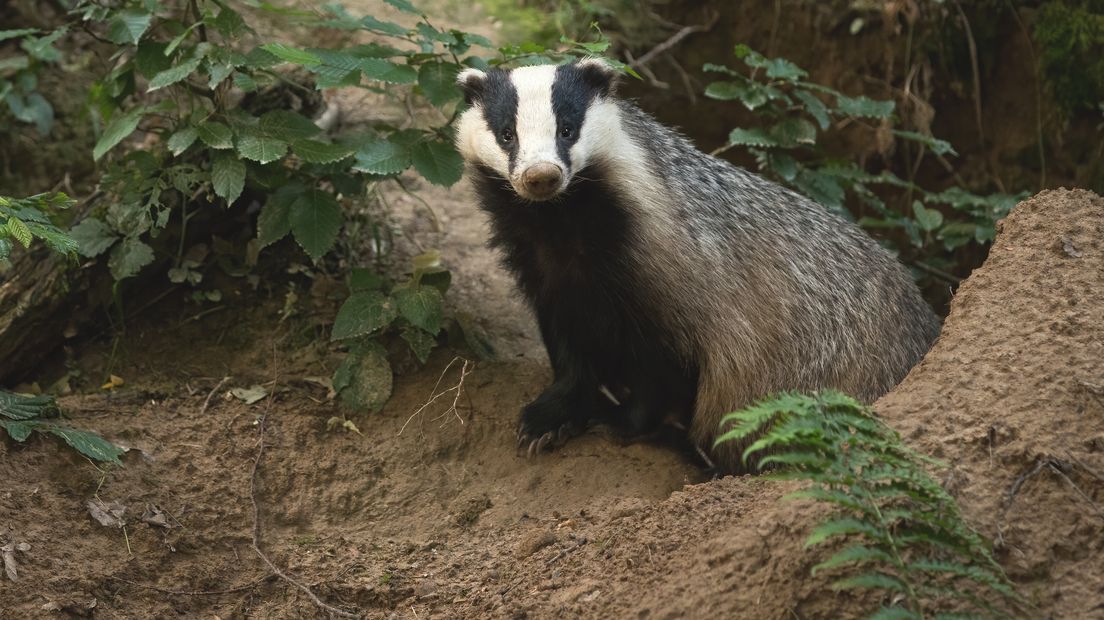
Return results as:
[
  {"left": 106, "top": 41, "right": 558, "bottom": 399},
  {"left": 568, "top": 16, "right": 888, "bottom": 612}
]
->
[{"left": 456, "top": 58, "right": 938, "bottom": 473}]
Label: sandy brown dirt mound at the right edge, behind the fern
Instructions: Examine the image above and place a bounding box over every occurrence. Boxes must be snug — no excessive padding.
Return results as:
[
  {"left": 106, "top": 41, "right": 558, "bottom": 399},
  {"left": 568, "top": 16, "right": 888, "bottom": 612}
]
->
[{"left": 877, "top": 190, "right": 1104, "bottom": 618}]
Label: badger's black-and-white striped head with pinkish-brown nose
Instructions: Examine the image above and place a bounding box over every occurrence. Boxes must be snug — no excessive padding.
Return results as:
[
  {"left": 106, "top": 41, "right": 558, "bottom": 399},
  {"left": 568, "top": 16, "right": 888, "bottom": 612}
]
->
[{"left": 456, "top": 58, "right": 616, "bottom": 201}]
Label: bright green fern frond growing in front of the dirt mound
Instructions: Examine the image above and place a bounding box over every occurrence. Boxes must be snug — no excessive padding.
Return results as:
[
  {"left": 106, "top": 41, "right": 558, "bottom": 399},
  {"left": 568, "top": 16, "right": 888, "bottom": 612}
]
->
[{"left": 716, "top": 392, "right": 1023, "bottom": 619}]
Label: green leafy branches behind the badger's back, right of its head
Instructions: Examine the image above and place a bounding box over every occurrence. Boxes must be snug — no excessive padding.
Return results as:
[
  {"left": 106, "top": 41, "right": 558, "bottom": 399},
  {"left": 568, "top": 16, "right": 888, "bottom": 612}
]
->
[{"left": 704, "top": 45, "right": 1023, "bottom": 270}]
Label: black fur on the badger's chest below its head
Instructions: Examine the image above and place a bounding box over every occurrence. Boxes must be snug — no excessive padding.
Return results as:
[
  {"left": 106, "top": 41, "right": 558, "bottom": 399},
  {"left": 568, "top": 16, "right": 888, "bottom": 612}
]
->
[{"left": 475, "top": 165, "right": 697, "bottom": 430}]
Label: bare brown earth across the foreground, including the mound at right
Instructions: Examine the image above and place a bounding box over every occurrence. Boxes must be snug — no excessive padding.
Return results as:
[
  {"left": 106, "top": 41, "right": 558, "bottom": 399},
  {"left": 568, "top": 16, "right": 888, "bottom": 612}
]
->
[{"left": 0, "top": 191, "right": 1104, "bottom": 619}]
